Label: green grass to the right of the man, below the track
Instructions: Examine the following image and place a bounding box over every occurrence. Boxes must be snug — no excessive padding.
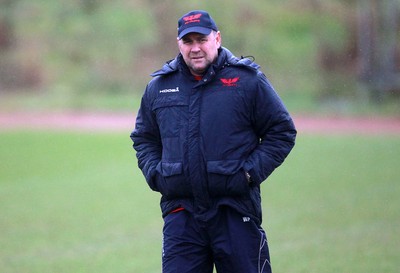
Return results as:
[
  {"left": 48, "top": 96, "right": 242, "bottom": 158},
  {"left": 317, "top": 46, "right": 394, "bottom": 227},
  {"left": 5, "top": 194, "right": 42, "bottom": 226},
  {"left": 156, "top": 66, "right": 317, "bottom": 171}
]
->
[{"left": 263, "top": 136, "right": 400, "bottom": 273}]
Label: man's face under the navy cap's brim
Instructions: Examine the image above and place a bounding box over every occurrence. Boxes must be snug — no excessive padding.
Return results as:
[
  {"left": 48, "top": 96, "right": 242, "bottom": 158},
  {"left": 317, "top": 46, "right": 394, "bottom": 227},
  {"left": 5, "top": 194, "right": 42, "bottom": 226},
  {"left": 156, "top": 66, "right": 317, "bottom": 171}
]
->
[{"left": 178, "top": 31, "right": 221, "bottom": 76}]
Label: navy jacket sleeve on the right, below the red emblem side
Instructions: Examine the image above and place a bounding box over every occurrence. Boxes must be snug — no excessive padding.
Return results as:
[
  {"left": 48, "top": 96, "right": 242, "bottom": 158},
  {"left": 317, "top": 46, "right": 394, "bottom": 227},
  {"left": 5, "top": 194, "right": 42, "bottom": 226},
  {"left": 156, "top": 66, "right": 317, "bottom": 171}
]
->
[{"left": 244, "top": 72, "right": 297, "bottom": 184}]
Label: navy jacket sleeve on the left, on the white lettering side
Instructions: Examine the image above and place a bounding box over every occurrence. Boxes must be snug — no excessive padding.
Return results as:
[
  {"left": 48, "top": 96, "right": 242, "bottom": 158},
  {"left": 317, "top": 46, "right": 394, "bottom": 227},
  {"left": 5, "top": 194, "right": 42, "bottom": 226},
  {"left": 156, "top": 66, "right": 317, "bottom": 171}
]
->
[{"left": 130, "top": 87, "right": 162, "bottom": 191}]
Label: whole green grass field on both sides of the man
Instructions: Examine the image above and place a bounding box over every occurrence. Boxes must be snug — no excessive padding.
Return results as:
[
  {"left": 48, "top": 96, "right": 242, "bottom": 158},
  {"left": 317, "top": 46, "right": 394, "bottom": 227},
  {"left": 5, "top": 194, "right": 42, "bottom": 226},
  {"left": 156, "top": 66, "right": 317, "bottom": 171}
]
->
[{"left": 0, "top": 131, "right": 400, "bottom": 273}]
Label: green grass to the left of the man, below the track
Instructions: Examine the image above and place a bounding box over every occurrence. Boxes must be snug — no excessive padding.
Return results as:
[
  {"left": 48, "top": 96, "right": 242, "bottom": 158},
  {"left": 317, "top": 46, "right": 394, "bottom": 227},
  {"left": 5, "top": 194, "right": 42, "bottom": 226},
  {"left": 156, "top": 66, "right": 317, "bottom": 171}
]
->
[{"left": 0, "top": 132, "right": 161, "bottom": 273}]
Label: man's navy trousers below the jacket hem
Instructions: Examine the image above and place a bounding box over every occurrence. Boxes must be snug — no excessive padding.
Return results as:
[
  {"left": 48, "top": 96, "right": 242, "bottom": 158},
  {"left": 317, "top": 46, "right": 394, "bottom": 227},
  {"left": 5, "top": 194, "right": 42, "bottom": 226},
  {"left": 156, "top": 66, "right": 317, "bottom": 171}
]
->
[{"left": 162, "top": 207, "right": 272, "bottom": 273}]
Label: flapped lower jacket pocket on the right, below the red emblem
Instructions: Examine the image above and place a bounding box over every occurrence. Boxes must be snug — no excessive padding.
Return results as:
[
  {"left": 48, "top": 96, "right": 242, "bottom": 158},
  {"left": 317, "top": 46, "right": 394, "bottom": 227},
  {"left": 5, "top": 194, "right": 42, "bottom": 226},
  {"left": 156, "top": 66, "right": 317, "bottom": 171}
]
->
[{"left": 207, "top": 160, "right": 249, "bottom": 197}]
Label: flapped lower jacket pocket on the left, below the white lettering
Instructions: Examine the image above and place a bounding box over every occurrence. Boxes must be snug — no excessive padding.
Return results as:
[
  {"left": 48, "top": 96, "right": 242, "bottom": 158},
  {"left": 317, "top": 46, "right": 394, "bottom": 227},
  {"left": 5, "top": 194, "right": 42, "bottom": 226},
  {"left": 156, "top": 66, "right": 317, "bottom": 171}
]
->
[{"left": 156, "top": 162, "right": 192, "bottom": 200}]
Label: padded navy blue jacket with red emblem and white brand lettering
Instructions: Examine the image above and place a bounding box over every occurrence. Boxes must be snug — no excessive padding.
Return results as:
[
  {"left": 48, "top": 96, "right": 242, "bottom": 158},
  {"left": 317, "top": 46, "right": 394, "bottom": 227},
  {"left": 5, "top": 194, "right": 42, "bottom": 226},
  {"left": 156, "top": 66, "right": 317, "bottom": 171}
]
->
[{"left": 131, "top": 48, "right": 296, "bottom": 223}]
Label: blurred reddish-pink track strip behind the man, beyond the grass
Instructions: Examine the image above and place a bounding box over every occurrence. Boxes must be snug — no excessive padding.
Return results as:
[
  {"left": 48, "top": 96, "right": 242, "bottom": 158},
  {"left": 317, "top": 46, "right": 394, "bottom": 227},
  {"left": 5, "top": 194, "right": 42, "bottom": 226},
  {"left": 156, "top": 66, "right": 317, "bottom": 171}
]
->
[{"left": 0, "top": 112, "right": 400, "bottom": 135}]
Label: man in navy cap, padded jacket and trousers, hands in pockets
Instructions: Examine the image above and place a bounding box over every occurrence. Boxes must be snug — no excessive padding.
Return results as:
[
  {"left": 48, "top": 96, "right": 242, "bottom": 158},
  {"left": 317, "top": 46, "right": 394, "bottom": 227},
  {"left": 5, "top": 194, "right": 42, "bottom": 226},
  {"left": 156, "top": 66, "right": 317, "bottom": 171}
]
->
[{"left": 131, "top": 10, "right": 296, "bottom": 273}]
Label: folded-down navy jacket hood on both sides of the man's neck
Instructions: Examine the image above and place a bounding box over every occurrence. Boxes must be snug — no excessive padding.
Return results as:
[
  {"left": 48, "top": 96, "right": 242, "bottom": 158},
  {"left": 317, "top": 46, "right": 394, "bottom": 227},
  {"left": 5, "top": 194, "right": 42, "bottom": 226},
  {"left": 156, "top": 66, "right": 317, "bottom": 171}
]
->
[{"left": 150, "top": 47, "right": 260, "bottom": 77}]
